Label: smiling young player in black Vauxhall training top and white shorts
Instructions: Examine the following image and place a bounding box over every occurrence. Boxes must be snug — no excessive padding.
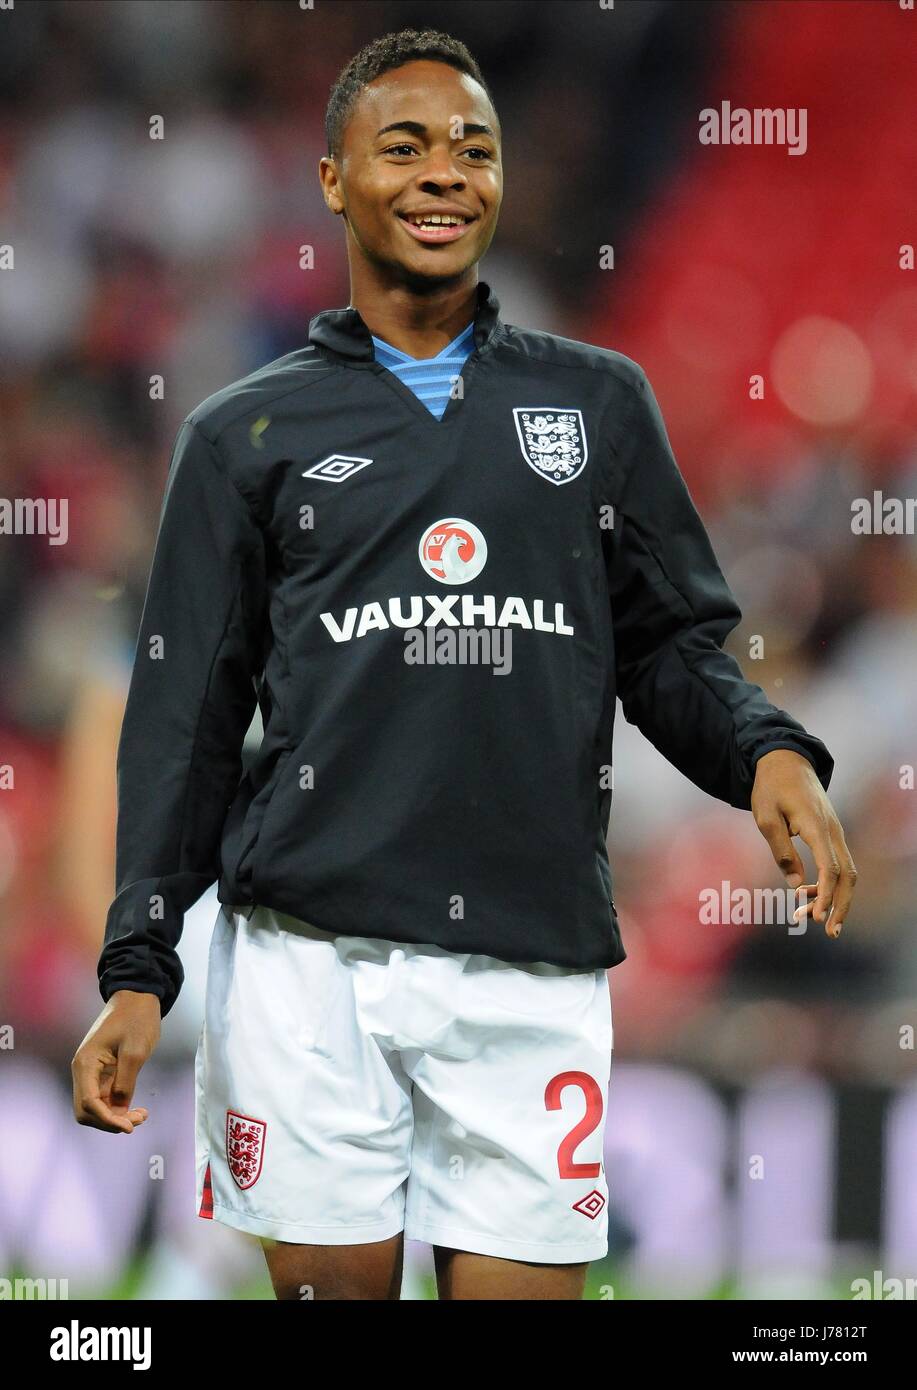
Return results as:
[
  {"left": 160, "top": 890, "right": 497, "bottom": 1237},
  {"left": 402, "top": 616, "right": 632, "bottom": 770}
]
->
[{"left": 74, "top": 31, "right": 853, "bottom": 1298}]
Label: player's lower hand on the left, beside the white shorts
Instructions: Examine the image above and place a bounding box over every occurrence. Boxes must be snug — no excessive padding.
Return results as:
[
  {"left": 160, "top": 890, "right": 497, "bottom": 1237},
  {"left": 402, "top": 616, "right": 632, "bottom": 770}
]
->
[{"left": 71, "top": 990, "right": 161, "bottom": 1134}]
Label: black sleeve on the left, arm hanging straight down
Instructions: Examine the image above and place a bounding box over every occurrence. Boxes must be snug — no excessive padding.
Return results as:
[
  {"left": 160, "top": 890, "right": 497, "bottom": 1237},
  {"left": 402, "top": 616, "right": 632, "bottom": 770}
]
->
[{"left": 99, "top": 417, "right": 267, "bottom": 1016}]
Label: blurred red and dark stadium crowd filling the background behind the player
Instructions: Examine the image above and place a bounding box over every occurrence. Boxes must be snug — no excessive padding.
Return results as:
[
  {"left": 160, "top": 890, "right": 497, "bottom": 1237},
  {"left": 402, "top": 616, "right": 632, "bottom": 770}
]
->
[{"left": 0, "top": 0, "right": 917, "bottom": 1301}]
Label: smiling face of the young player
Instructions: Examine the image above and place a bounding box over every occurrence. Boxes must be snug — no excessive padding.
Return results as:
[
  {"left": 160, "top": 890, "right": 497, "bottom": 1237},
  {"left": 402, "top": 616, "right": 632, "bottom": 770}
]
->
[{"left": 321, "top": 60, "right": 503, "bottom": 285}]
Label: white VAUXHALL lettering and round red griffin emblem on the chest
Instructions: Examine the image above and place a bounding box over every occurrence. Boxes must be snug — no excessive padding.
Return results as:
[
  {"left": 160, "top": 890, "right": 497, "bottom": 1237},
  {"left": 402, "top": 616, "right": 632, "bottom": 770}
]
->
[{"left": 320, "top": 517, "right": 574, "bottom": 642}]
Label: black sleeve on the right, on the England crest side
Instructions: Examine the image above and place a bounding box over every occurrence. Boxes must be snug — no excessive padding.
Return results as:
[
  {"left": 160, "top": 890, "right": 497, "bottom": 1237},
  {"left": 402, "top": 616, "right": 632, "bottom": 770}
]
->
[{"left": 606, "top": 370, "right": 834, "bottom": 809}]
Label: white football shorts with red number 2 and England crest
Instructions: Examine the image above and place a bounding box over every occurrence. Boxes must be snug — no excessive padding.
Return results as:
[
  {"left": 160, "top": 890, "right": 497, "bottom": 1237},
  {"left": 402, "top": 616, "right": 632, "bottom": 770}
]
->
[{"left": 196, "top": 908, "right": 613, "bottom": 1265}]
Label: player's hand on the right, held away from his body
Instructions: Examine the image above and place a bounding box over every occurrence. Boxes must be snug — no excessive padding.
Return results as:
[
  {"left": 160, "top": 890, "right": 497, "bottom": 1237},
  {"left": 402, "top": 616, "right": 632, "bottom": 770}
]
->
[{"left": 752, "top": 748, "right": 857, "bottom": 937}]
